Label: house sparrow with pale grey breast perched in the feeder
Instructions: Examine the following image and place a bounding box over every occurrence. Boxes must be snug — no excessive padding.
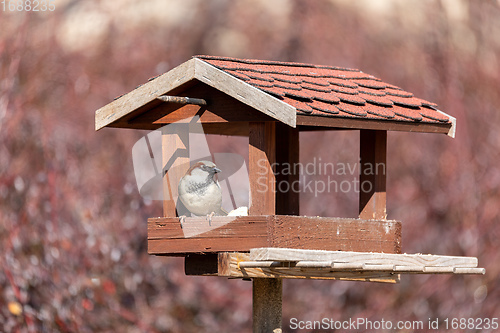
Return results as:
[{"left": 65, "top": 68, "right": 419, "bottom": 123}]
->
[{"left": 179, "top": 161, "right": 227, "bottom": 218}]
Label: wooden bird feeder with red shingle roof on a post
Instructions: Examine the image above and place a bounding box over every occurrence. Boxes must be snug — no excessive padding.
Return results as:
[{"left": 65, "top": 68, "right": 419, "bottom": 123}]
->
[{"left": 95, "top": 56, "right": 484, "bottom": 332}]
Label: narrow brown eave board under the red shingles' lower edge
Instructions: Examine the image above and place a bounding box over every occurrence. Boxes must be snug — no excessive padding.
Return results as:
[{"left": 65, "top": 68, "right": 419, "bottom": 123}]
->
[{"left": 296, "top": 115, "right": 454, "bottom": 137}]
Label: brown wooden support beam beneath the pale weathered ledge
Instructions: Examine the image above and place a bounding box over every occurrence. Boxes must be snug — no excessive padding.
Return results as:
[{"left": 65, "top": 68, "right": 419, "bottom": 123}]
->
[{"left": 218, "top": 252, "right": 399, "bottom": 283}]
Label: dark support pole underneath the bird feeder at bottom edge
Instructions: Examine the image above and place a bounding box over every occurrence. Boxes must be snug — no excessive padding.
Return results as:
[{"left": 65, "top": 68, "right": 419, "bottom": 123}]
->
[{"left": 252, "top": 278, "right": 283, "bottom": 333}]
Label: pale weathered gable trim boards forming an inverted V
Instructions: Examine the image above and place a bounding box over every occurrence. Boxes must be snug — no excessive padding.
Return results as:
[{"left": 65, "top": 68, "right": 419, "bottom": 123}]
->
[{"left": 95, "top": 59, "right": 296, "bottom": 130}]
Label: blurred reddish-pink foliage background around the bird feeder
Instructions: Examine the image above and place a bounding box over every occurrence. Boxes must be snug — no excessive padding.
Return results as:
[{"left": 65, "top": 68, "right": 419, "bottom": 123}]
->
[{"left": 0, "top": 0, "right": 500, "bottom": 332}]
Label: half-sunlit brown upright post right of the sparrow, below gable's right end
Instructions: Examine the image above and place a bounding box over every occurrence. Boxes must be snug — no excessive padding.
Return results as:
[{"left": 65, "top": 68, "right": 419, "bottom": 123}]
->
[{"left": 248, "top": 122, "right": 276, "bottom": 215}]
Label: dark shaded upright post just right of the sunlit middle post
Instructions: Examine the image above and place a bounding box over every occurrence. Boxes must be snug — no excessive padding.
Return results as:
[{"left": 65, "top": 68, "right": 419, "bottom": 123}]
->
[{"left": 275, "top": 123, "right": 300, "bottom": 215}]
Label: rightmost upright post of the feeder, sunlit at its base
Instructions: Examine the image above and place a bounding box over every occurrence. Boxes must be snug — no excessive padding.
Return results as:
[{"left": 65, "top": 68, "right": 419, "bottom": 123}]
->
[{"left": 359, "top": 130, "right": 387, "bottom": 220}]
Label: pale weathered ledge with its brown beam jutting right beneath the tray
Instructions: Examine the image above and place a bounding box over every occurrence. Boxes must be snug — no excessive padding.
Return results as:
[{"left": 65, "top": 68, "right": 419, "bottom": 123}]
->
[{"left": 212, "top": 248, "right": 485, "bottom": 283}]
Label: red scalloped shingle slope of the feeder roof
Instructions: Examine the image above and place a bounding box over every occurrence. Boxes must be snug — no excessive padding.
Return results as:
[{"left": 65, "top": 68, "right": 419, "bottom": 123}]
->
[{"left": 196, "top": 56, "right": 450, "bottom": 124}]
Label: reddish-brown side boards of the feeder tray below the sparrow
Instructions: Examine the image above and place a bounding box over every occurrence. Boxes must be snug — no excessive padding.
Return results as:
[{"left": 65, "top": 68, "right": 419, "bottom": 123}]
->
[{"left": 148, "top": 215, "right": 401, "bottom": 255}]
